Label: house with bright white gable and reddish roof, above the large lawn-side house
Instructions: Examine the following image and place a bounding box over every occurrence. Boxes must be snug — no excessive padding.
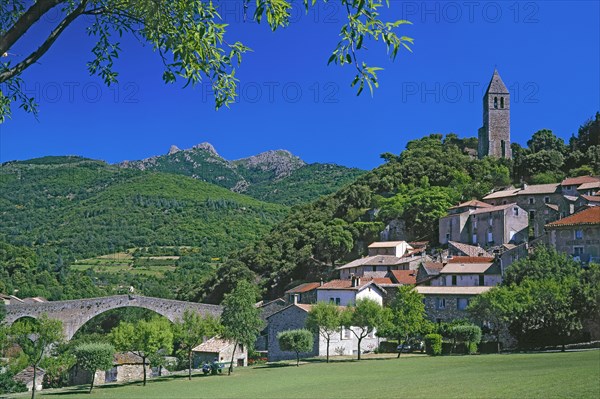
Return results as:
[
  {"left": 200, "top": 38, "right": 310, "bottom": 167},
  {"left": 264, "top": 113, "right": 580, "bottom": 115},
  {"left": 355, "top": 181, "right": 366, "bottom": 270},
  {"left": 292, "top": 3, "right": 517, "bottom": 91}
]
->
[{"left": 316, "top": 277, "right": 386, "bottom": 306}]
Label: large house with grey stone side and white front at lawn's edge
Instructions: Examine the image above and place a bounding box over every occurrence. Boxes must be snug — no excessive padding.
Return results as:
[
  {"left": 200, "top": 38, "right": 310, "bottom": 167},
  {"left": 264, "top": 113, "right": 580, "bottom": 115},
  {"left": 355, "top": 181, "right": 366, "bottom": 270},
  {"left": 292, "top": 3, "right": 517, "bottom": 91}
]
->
[{"left": 268, "top": 303, "right": 381, "bottom": 362}]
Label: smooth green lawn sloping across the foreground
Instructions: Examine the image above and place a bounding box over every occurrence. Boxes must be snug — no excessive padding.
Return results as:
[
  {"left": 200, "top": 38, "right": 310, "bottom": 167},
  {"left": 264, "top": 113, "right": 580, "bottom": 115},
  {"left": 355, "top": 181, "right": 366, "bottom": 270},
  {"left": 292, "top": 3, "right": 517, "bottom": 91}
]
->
[{"left": 31, "top": 350, "right": 600, "bottom": 399}]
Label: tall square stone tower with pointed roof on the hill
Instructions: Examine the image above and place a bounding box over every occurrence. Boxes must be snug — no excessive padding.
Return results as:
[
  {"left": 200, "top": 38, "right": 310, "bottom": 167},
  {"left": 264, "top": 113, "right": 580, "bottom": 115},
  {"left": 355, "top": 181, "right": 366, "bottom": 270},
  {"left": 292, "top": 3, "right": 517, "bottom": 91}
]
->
[{"left": 477, "top": 69, "right": 512, "bottom": 159}]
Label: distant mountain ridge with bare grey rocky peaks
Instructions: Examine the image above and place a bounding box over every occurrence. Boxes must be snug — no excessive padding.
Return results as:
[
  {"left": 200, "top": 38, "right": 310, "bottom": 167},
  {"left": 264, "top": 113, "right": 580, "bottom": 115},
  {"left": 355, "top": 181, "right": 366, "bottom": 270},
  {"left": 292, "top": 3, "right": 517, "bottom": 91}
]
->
[{"left": 119, "top": 143, "right": 366, "bottom": 205}]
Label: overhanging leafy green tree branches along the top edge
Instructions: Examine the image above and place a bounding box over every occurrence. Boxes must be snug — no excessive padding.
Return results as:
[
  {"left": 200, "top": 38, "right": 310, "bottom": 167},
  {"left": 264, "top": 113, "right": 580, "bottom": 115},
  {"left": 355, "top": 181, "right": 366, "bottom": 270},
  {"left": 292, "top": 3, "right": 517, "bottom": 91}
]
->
[{"left": 0, "top": 0, "right": 413, "bottom": 122}]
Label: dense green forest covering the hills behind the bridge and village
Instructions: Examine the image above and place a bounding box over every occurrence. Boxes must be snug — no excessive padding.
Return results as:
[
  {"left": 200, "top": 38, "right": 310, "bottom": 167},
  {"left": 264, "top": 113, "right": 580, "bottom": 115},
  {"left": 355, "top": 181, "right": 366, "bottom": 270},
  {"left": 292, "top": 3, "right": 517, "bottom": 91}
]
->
[{"left": 0, "top": 113, "right": 600, "bottom": 303}]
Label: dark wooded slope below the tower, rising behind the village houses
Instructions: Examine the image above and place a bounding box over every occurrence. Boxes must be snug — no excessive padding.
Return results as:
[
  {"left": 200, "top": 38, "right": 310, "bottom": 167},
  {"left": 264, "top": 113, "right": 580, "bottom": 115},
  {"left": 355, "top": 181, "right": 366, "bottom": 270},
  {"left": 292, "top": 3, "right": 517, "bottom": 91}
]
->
[{"left": 204, "top": 113, "right": 600, "bottom": 302}]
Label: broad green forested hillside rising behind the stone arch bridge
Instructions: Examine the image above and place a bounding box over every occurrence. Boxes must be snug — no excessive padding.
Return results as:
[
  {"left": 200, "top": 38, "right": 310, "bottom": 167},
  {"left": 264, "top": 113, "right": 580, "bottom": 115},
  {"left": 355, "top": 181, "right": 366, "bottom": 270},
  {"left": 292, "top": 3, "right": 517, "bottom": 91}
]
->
[{"left": 0, "top": 157, "right": 287, "bottom": 299}]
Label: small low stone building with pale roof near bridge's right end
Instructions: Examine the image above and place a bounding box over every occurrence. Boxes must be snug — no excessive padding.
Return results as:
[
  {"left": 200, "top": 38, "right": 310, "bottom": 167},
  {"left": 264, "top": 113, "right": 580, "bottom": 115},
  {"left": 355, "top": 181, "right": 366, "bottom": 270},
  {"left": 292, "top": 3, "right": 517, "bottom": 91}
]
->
[{"left": 192, "top": 337, "right": 248, "bottom": 368}]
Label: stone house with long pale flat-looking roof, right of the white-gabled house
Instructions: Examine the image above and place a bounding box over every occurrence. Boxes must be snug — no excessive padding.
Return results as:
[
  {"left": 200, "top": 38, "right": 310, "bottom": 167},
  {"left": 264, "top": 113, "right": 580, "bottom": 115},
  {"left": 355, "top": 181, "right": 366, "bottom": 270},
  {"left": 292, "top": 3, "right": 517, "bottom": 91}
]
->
[{"left": 415, "top": 285, "right": 493, "bottom": 323}]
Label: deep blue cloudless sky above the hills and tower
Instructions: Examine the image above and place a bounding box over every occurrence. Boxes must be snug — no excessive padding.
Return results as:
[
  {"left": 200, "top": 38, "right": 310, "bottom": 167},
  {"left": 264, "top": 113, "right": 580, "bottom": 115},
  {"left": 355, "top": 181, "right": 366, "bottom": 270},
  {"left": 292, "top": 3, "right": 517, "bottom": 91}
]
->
[{"left": 0, "top": 0, "right": 600, "bottom": 169}]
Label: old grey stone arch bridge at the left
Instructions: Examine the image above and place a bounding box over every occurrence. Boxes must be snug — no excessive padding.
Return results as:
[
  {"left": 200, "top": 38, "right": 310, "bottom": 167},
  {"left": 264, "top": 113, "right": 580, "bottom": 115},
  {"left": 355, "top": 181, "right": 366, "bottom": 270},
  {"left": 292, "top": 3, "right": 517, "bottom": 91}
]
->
[{"left": 4, "top": 295, "right": 222, "bottom": 340}]
